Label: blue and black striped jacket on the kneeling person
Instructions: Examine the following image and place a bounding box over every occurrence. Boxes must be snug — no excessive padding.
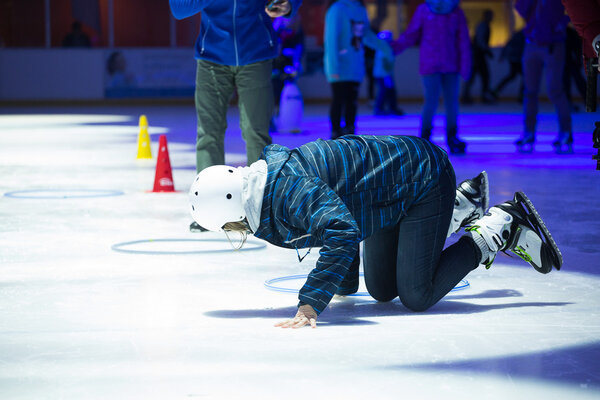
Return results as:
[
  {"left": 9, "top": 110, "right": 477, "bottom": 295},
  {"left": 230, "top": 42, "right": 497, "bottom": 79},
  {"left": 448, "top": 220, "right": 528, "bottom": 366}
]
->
[{"left": 254, "top": 136, "right": 452, "bottom": 313}]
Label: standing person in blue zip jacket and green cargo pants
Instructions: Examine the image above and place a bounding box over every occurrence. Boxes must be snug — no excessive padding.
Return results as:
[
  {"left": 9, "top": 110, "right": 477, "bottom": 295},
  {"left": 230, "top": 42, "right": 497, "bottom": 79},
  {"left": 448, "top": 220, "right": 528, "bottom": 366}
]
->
[{"left": 169, "top": 0, "right": 302, "bottom": 231}]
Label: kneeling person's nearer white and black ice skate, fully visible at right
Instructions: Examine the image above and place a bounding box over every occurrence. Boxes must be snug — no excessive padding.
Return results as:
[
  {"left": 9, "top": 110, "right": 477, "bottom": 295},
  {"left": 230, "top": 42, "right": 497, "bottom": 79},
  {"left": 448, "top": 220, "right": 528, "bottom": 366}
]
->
[{"left": 467, "top": 192, "right": 563, "bottom": 274}]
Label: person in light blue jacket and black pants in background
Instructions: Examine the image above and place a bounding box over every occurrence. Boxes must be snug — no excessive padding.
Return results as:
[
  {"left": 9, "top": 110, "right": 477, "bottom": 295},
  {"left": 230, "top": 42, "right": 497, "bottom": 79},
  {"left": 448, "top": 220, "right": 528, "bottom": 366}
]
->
[{"left": 324, "top": 0, "right": 389, "bottom": 139}]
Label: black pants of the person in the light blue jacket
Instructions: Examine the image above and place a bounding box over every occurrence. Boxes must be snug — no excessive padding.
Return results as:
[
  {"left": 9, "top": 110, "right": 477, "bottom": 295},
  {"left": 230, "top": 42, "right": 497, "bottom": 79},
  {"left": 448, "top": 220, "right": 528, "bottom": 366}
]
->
[{"left": 329, "top": 81, "right": 360, "bottom": 139}]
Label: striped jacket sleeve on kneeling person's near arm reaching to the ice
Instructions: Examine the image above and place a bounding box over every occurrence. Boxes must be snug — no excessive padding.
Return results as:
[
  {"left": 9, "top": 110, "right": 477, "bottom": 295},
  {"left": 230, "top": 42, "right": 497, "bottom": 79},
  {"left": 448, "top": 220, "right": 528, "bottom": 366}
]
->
[{"left": 284, "top": 177, "right": 360, "bottom": 314}]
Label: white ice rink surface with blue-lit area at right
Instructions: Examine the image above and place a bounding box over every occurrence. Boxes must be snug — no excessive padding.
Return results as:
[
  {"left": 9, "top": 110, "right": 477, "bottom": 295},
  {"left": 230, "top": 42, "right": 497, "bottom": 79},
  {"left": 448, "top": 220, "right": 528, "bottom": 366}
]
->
[{"left": 0, "top": 104, "right": 600, "bottom": 400}]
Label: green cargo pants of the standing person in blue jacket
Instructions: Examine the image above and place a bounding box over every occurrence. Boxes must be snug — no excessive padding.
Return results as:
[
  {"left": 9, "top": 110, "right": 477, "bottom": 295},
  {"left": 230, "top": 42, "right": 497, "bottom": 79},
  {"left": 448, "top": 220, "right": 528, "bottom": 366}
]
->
[{"left": 195, "top": 60, "right": 273, "bottom": 172}]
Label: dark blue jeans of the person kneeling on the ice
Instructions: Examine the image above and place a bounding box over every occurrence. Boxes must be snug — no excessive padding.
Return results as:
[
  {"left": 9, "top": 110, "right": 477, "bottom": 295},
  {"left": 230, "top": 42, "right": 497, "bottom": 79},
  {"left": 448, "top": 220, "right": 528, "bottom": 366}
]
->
[{"left": 363, "top": 165, "right": 481, "bottom": 311}]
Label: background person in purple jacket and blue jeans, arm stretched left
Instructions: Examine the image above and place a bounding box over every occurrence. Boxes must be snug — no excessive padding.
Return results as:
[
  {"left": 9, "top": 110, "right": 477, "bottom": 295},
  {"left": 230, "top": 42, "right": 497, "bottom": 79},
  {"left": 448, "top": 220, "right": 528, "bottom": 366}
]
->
[{"left": 392, "top": 0, "right": 471, "bottom": 154}]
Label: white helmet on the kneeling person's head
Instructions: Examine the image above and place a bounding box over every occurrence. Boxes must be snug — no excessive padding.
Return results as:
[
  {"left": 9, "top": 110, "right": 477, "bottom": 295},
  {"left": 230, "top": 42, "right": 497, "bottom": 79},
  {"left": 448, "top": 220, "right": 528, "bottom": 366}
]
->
[{"left": 189, "top": 165, "right": 246, "bottom": 232}]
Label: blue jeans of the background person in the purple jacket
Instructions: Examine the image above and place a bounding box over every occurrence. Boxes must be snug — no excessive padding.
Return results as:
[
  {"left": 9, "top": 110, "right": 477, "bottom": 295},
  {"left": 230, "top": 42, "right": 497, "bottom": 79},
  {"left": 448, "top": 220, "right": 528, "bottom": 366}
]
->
[{"left": 421, "top": 73, "right": 459, "bottom": 137}]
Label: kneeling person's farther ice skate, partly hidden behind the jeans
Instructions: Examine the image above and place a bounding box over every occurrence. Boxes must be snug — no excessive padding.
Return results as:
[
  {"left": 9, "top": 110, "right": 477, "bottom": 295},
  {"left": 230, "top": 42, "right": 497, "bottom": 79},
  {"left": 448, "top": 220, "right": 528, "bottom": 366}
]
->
[{"left": 448, "top": 171, "right": 490, "bottom": 236}]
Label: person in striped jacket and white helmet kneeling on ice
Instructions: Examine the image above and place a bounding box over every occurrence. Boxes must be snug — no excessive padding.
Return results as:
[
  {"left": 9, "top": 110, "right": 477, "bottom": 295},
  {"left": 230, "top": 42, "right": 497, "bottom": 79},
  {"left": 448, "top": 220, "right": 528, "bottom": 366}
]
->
[{"left": 189, "top": 136, "right": 562, "bottom": 328}]
